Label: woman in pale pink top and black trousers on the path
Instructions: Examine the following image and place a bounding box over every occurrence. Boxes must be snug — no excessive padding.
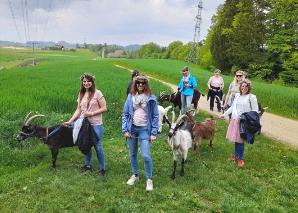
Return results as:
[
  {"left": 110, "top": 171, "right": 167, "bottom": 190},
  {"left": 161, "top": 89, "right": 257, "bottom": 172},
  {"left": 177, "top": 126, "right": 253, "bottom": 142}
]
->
[{"left": 207, "top": 69, "right": 224, "bottom": 112}]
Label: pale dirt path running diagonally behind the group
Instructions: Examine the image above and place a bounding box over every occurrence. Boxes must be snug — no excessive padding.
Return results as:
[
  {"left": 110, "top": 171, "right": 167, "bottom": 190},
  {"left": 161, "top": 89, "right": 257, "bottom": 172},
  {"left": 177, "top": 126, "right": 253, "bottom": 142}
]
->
[{"left": 115, "top": 65, "right": 298, "bottom": 149}]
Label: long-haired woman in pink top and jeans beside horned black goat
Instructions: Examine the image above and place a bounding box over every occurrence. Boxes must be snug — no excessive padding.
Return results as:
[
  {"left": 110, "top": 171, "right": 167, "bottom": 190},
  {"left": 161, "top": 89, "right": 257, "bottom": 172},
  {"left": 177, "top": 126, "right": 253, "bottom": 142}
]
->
[{"left": 64, "top": 73, "right": 107, "bottom": 176}]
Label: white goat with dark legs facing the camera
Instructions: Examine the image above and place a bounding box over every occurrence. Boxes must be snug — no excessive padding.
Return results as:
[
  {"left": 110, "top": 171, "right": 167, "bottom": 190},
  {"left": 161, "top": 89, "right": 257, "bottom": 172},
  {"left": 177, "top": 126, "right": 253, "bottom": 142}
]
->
[{"left": 168, "top": 111, "right": 192, "bottom": 179}]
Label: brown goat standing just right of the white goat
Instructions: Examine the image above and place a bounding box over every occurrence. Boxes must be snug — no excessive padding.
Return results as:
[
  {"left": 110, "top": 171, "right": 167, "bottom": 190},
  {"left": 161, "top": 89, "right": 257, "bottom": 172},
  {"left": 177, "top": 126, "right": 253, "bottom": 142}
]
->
[{"left": 185, "top": 111, "right": 216, "bottom": 155}]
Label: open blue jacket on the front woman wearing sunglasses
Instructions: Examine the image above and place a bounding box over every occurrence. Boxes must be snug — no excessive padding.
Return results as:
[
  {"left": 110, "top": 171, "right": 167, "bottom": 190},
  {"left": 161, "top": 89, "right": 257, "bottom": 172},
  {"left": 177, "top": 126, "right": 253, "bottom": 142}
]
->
[{"left": 122, "top": 94, "right": 158, "bottom": 136}]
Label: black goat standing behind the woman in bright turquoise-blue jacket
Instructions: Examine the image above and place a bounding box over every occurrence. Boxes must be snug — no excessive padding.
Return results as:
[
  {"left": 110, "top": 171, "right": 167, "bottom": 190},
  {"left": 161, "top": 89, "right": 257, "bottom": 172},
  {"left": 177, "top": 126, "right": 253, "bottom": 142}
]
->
[{"left": 158, "top": 89, "right": 205, "bottom": 110}]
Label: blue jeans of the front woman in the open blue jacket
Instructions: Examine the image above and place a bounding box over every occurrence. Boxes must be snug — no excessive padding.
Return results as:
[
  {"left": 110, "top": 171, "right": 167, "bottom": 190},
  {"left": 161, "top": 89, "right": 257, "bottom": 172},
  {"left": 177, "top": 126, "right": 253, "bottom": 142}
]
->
[{"left": 127, "top": 125, "right": 152, "bottom": 179}]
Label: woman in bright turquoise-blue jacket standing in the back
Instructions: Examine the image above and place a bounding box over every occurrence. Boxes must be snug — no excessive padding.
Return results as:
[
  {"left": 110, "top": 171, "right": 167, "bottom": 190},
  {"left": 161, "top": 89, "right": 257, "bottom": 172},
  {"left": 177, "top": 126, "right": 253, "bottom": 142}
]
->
[{"left": 178, "top": 67, "right": 198, "bottom": 113}]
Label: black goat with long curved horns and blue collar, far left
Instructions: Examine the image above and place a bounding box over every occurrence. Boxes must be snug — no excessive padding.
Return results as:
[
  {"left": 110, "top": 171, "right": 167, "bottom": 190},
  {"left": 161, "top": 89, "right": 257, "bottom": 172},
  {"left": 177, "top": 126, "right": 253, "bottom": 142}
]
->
[{"left": 16, "top": 113, "right": 76, "bottom": 168}]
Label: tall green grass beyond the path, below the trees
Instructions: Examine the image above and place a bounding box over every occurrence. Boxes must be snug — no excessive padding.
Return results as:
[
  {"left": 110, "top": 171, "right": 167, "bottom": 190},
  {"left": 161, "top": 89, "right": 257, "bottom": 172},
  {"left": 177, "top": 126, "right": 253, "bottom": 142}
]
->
[{"left": 112, "top": 59, "right": 298, "bottom": 119}]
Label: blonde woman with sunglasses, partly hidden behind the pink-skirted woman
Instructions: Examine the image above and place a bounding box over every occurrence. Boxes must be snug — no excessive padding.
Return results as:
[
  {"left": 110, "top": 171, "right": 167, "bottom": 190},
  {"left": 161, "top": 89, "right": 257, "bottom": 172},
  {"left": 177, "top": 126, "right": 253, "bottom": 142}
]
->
[{"left": 224, "top": 70, "right": 245, "bottom": 109}]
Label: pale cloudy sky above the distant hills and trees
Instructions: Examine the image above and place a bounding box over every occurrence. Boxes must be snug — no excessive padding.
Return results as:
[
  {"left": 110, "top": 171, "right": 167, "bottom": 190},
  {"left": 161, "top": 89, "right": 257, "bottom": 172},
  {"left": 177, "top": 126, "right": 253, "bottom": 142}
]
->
[{"left": 0, "top": 0, "right": 224, "bottom": 46}]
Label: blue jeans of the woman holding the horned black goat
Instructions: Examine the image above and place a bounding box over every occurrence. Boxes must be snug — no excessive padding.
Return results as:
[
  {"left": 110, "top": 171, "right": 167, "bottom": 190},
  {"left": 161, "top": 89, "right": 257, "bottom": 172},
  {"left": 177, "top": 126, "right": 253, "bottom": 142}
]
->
[{"left": 85, "top": 125, "right": 105, "bottom": 170}]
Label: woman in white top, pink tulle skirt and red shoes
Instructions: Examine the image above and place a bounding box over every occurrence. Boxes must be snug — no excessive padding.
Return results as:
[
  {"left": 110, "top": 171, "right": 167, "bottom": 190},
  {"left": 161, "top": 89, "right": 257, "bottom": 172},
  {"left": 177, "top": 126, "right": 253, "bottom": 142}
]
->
[{"left": 220, "top": 80, "right": 259, "bottom": 167}]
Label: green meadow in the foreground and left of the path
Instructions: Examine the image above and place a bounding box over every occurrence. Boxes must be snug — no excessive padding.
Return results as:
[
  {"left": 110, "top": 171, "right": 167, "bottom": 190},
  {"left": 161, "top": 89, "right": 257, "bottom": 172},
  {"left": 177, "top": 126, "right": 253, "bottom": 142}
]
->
[{"left": 0, "top": 48, "right": 298, "bottom": 212}]
